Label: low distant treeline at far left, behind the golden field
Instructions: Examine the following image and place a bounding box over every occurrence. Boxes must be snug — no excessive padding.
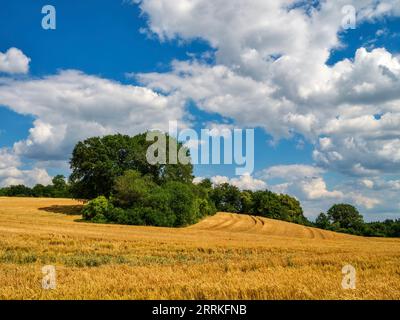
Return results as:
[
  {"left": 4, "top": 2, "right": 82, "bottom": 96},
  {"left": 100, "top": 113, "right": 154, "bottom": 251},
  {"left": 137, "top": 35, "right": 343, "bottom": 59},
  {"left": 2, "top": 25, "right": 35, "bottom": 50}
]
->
[{"left": 0, "top": 175, "right": 72, "bottom": 198}]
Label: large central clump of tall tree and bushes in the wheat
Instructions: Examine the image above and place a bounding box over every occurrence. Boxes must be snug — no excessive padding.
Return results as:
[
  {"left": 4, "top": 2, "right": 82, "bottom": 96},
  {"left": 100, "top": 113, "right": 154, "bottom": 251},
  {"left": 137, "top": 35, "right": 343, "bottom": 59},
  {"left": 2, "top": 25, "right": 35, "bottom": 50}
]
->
[{"left": 70, "top": 134, "right": 216, "bottom": 227}]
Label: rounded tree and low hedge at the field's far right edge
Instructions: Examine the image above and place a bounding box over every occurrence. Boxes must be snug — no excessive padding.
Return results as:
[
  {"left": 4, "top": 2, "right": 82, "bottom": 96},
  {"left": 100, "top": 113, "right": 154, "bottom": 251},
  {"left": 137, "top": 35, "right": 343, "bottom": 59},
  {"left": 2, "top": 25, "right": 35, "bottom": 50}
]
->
[{"left": 315, "top": 204, "right": 400, "bottom": 237}]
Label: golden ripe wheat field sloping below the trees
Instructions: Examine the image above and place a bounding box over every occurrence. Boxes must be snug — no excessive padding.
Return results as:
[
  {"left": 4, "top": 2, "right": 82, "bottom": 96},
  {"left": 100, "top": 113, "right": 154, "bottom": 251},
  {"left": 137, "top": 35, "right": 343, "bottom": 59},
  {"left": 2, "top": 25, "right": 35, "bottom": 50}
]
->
[{"left": 0, "top": 198, "right": 400, "bottom": 299}]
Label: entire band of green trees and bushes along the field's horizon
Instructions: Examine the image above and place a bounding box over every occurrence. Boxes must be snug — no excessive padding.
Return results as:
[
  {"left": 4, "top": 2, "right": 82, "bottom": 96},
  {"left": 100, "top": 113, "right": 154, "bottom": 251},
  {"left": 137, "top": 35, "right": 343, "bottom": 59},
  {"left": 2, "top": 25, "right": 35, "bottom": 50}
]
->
[{"left": 0, "top": 133, "right": 400, "bottom": 237}]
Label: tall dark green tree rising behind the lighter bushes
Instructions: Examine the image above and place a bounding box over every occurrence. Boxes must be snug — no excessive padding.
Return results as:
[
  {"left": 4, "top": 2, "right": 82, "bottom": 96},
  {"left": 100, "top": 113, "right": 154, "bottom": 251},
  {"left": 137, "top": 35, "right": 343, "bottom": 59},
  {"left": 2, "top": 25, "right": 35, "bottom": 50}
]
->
[{"left": 70, "top": 133, "right": 193, "bottom": 199}]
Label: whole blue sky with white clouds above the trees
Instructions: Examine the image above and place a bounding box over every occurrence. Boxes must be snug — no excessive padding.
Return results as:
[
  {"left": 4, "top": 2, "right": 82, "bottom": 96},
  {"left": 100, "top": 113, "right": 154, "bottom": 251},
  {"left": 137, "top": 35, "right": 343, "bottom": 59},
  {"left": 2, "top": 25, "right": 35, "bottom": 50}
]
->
[{"left": 0, "top": 0, "right": 400, "bottom": 220}]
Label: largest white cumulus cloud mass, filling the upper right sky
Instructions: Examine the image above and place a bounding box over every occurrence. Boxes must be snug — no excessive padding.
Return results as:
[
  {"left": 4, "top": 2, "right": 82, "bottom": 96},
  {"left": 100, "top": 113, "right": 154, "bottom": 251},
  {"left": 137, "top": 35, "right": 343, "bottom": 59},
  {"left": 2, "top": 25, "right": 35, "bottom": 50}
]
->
[{"left": 137, "top": 0, "right": 400, "bottom": 175}]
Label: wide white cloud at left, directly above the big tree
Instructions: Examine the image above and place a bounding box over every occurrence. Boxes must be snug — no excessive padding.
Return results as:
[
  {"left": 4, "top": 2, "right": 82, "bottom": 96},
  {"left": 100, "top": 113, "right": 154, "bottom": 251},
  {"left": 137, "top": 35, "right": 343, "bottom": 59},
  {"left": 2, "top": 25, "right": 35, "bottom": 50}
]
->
[{"left": 0, "top": 70, "right": 185, "bottom": 160}]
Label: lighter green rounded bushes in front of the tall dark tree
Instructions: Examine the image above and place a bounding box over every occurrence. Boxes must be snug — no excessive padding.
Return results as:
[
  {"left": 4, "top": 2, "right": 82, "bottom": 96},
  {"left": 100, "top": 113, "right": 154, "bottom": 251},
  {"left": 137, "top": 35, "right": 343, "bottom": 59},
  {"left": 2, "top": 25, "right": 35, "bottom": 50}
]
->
[{"left": 83, "top": 170, "right": 215, "bottom": 227}]
